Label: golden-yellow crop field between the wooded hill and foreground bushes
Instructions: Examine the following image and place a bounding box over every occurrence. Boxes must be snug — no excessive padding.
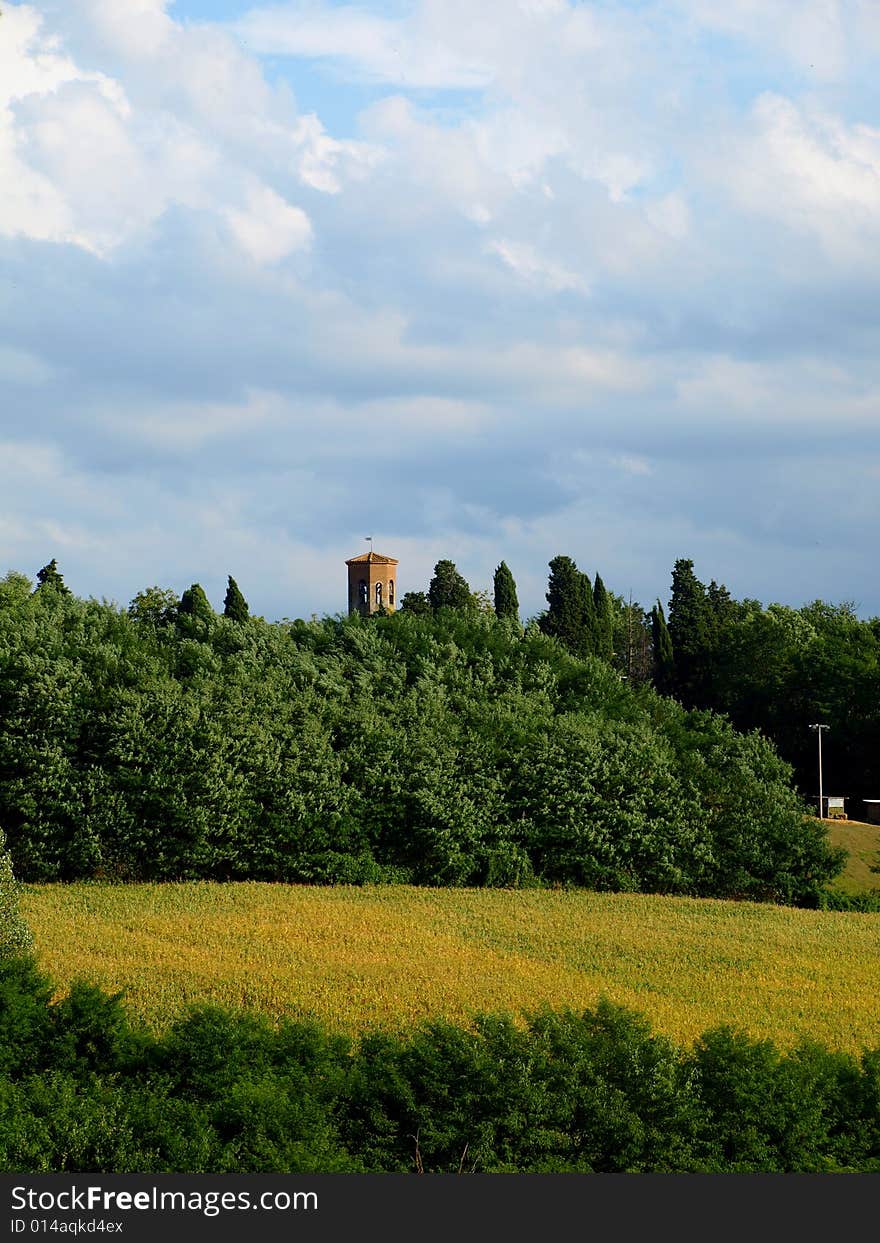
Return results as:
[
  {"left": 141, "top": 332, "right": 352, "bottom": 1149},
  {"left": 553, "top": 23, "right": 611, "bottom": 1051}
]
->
[{"left": 22, "top": 883, "right": 880, "bottom": 1052}]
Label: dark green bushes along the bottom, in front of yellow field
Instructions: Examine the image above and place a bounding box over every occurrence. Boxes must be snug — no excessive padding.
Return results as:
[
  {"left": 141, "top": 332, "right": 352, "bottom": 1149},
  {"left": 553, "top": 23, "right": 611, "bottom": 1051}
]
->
[{"left": 0, "top": 958, "right": 880, "bottom": 1173}]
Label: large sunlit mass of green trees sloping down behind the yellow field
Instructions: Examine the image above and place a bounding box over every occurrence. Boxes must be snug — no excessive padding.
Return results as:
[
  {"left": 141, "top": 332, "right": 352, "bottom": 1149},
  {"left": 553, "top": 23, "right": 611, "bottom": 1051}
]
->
[{"left": 0, "top": 574, "right": 840, "bottom": 905}]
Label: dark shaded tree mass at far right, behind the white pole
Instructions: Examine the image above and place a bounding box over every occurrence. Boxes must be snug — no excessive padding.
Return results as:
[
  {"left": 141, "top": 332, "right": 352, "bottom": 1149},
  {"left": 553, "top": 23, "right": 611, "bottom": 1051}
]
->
[{"left": 654, "top": 561, "right": 880, "bottom": 819}]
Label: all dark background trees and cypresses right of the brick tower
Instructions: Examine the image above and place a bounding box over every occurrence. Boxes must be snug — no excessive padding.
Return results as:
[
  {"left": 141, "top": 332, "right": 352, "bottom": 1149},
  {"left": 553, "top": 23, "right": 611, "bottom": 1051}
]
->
[{"left": 413, "top": 557, "right": 880, "bottom": 819}]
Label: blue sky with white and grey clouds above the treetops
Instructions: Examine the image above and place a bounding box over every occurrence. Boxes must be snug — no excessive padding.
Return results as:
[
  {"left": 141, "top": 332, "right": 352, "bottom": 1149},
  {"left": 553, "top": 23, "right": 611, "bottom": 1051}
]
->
[{"left": 0, "top": 0, "right": 880, "bottom": 619}]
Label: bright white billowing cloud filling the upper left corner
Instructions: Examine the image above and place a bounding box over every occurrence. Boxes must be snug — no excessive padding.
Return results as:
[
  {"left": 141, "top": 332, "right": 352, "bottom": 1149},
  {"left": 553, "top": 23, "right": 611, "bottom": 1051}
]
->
[{"left": 0, "top": 0, "right": 367, "bottom": 254}]
